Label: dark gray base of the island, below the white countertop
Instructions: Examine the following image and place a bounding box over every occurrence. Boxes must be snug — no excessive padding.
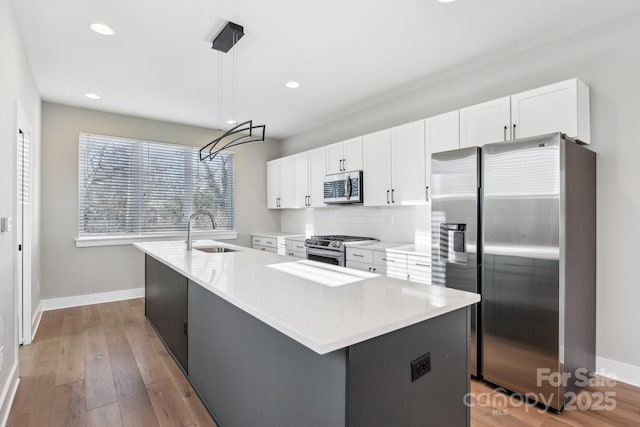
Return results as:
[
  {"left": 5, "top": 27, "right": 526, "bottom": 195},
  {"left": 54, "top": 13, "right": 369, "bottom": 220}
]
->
[{"left": 145, "top": 246, "right": 478, "bottom": 427}]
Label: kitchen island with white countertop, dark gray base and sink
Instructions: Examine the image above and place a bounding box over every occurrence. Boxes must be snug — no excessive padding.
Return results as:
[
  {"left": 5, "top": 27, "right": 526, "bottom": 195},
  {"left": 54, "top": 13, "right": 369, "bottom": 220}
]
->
[{"left": 136, "top": 241, "right": 480, "bottom": 427}]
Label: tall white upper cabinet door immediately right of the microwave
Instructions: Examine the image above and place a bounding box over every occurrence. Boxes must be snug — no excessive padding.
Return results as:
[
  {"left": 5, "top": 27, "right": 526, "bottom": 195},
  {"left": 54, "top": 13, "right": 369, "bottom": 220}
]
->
[{"left": 363, "top": 129, "right": 391, "bottom": 206}]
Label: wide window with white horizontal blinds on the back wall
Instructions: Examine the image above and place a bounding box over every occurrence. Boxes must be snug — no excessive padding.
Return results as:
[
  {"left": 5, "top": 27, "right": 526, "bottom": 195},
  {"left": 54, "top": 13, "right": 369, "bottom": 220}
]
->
[{"left": 78, "top": 133, "right": 235, "bottom": 246}]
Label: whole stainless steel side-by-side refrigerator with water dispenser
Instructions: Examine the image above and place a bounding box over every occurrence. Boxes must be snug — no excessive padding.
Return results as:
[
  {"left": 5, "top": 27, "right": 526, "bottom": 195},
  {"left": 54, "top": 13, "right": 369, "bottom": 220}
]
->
[{"left": 432, "top": 133, "right": 596, "bottom": 410}]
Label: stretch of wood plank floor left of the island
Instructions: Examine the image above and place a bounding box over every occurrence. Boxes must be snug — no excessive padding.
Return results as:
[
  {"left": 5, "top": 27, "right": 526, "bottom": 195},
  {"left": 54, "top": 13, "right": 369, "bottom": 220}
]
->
[{"left": 8, "top": 299, "right": 215, "bottom": 427}]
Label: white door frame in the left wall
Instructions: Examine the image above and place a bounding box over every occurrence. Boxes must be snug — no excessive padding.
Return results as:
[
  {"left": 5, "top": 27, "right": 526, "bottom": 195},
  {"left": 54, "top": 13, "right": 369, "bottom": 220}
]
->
[{"left": 13, "top": 102, "right": 34, "bottom": 345}]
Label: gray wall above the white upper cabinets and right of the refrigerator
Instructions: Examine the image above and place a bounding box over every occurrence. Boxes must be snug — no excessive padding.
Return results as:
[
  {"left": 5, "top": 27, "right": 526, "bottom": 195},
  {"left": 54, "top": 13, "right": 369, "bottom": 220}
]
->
[{"left": 282, "top": 14, "right": 640, "bottom": 372}]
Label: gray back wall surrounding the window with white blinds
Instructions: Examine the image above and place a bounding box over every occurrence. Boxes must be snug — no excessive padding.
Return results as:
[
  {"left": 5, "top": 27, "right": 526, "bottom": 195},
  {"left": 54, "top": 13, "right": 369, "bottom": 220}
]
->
[{"left": 42, "top": 102, "right": 280, "bottom": 299}]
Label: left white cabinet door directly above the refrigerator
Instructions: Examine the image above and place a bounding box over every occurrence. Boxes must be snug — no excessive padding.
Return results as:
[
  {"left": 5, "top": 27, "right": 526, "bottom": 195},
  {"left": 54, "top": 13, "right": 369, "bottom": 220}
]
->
[{"left": 460, "top": 96, "right": 511, "bottom": 148}]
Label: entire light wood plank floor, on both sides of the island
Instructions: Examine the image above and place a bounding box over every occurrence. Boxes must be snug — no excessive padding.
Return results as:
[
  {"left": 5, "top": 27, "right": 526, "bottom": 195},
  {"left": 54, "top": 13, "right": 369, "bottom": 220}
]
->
[{"left": 8, "top": 299, "right": 640, "bottom": 427}]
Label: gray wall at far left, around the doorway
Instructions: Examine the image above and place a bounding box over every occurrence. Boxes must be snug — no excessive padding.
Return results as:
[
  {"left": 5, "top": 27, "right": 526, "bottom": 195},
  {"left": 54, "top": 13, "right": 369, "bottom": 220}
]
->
[{"left": 0, "top": 0, "right": 40, "bottom": 417}]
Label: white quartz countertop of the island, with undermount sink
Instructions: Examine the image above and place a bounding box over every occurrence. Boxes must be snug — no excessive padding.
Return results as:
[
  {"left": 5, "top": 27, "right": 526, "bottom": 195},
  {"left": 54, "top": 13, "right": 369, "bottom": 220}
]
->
[{"left": 135, "top": 241, "right": 480, "bottom": 354}]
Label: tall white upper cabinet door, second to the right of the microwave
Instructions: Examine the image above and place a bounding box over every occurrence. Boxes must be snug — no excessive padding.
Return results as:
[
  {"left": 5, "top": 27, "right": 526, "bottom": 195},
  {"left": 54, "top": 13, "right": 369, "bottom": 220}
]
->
[{"left": 390, "top": 120, "right": 427, "bottom": 205}]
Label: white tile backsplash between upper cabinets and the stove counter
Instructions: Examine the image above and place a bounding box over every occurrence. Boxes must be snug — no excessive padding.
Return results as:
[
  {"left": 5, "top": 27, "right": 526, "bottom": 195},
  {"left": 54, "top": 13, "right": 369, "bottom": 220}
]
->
[{"left": 280, "top": 205, "right": 431, "bottom": 246}]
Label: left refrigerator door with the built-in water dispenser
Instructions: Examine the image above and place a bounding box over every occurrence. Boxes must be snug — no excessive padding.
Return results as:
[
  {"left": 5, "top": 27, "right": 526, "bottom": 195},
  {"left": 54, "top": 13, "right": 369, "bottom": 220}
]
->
[{"left": 431, "top": 147, "right": 481, "bottom": 377}]
